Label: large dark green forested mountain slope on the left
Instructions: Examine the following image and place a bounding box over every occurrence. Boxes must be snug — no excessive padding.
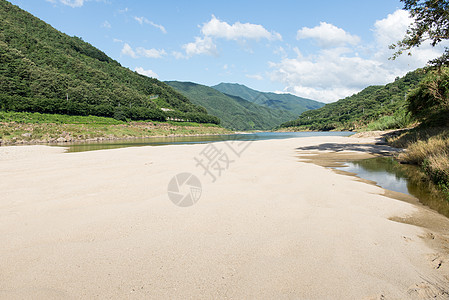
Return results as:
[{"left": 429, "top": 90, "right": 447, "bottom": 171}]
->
[{"left": 0, "top": 0, "right": 219, "bottom": 123}]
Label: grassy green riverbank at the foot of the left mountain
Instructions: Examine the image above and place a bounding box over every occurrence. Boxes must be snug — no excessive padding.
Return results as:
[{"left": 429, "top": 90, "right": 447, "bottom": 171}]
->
[{"left": 0, "top": 111, "right": 232, "bottom": 144}]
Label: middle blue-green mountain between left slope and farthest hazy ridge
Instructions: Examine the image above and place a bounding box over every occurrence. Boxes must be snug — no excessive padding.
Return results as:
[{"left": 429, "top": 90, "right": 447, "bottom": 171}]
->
[{"left": 166, "top": 81, "right": 297, "bottom": 130}]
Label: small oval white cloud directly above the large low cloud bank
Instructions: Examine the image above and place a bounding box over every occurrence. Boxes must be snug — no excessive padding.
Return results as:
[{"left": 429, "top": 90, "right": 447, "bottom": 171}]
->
[{"left": 296, "top": 22, "right": 360, "bottom": 48}]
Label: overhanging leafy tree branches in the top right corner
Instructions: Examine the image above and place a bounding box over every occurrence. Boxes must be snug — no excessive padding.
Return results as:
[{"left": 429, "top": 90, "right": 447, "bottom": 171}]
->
[{"left": 390, "top": 0, "right": 449, "bottom": 67}]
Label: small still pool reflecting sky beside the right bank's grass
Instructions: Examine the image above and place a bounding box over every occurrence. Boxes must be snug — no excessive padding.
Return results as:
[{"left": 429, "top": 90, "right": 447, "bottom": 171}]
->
[{"left": 336, "top": 157, "right": 449, "bottom": 217}]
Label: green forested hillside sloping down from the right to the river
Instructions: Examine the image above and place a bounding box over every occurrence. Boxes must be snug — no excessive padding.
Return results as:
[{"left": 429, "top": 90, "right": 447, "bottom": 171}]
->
[{"left": 282, "top": 69, "right": 425, "bottom": 130}]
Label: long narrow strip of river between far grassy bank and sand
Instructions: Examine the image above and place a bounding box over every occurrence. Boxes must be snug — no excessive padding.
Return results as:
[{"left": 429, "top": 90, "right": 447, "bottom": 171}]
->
[{"left": 58, "top": 131, "right": 354, "bottom": 152}]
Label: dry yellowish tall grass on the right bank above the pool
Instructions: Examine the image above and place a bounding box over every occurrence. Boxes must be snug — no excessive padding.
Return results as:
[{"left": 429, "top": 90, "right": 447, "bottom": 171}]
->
[{"left": 387, "top": 127, "right": 449, "bottom": 199}]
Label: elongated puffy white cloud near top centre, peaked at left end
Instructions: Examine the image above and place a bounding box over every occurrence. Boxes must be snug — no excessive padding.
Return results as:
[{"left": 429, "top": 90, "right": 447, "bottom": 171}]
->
[{"left": 201, "top": 15, "right": 282, "bottom": 40}]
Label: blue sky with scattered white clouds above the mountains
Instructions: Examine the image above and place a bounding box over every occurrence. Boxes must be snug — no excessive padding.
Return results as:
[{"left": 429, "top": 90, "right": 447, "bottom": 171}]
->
[{"left": 7, "top": 0, "right": 442, "bottom": 102}]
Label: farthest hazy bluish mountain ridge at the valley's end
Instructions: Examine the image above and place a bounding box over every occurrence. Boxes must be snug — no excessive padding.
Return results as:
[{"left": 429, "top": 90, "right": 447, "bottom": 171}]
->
[{"left": 213, "top": 83, "right": 324, "bottom": 116}]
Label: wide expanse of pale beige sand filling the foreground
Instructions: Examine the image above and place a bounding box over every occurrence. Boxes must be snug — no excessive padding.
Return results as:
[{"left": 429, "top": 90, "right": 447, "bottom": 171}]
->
[{"left": 0, "top": 137, "right": 449, "bottom": 299}]
